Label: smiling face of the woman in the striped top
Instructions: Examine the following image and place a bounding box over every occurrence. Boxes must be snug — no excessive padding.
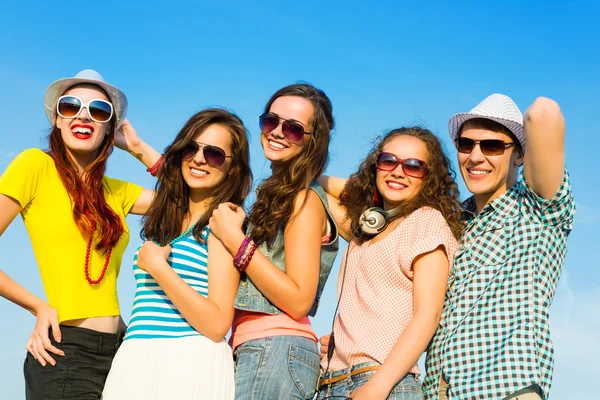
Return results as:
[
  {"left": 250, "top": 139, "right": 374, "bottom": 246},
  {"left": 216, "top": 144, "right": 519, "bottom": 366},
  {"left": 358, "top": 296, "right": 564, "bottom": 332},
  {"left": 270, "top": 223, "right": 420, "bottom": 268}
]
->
[{"left": 181, "top": 124, "right": 232, "bottom": 198}]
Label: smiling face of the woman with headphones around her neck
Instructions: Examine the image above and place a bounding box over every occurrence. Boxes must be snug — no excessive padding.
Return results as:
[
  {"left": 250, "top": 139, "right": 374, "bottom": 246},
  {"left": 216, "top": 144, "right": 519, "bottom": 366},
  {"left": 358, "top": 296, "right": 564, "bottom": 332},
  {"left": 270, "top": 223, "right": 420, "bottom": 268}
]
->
[{"left": 376, "top": 135, "right": 429, "bottom": 210}]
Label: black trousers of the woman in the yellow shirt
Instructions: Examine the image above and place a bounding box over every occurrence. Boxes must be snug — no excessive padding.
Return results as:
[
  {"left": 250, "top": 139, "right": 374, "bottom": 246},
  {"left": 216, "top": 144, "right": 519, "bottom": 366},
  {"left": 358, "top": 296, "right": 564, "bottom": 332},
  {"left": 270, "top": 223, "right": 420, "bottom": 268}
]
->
[{"left": 23, "top": 325, "right": 122, "bottom": 400}]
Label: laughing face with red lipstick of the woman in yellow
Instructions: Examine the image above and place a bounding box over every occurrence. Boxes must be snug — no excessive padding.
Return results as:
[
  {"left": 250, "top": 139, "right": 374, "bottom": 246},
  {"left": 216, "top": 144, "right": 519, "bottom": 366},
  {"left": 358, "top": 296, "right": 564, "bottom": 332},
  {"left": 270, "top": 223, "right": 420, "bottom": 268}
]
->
[{"left": 56, "top": 84, "right": 114, "bottom": 158}]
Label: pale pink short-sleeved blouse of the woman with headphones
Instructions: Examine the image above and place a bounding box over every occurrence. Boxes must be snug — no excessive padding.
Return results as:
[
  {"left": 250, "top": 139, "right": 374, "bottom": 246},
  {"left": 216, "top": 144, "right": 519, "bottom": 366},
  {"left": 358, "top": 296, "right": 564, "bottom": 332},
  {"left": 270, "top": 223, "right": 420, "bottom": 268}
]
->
[{"left": 321, "top": 207, "right": 458, "bottom": 374}]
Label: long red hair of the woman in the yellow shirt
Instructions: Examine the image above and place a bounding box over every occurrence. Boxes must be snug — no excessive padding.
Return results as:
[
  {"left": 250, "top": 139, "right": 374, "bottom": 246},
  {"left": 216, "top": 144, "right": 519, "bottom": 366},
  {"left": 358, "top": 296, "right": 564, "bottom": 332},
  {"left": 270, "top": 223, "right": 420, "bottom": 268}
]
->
[{"left": 47, "top": 85, "right": 124, "bottom": 250}]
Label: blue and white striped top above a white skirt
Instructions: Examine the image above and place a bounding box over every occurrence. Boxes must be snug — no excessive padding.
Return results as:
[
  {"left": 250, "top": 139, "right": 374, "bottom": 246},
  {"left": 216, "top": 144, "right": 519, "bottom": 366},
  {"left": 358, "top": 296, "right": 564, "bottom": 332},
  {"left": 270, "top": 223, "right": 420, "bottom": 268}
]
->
[{"left": 124, "top": 227, "right": 210, "bottom": 340}]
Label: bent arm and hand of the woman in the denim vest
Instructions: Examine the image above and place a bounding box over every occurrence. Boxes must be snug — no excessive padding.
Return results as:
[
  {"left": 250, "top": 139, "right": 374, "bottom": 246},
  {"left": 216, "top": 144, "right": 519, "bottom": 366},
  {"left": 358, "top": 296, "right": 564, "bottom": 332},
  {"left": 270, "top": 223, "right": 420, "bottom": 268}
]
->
[{"left": 210, "top": 190, "right": 327, "bottom": 319}]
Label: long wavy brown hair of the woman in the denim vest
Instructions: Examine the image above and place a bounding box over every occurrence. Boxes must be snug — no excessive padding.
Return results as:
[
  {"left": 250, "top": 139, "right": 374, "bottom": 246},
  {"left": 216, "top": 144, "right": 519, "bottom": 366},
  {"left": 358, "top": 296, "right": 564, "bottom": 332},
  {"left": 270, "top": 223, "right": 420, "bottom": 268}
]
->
[{"left": 248, "top": 83, "right": 335, "bottom": 245}]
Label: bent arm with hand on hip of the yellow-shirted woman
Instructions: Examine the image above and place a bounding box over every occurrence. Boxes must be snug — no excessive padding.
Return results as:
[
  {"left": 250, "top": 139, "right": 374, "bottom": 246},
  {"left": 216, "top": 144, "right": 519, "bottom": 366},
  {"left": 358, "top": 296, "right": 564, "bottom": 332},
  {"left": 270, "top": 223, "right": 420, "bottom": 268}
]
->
[{"left": 0, "top": 194, "right": 64, "bottom": 366}]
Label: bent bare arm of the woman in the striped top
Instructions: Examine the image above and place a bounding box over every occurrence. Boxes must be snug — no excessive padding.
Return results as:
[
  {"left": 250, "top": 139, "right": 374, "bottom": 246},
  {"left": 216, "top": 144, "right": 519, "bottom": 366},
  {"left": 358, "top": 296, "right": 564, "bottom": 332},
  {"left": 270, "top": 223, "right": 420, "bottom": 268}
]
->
[{"left": 138, "top": 235, "right": 240, "bottom": 342}]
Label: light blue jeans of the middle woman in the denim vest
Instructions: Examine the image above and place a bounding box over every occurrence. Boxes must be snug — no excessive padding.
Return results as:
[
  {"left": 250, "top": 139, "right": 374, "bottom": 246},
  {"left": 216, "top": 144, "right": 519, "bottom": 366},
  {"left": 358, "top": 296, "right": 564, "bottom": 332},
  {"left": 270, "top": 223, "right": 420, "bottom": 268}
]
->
[{"left": 234, "top": 336, "right": 320, "bottom": 400}]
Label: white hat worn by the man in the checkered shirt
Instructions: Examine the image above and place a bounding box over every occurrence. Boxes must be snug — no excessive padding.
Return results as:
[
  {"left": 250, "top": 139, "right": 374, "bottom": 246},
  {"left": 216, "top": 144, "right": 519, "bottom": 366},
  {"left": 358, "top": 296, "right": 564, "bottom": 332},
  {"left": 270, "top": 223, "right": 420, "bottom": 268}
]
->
[{"left": 448, "top": 93, "right": 525, "bottom": 151}]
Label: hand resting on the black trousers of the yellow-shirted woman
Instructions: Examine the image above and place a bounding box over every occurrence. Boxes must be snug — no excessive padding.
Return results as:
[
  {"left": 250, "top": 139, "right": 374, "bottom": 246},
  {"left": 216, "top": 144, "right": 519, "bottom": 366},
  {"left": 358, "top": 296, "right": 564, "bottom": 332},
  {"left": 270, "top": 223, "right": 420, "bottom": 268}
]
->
[{"left": 25, "top": 303, "right": 65, "bottom": 367}]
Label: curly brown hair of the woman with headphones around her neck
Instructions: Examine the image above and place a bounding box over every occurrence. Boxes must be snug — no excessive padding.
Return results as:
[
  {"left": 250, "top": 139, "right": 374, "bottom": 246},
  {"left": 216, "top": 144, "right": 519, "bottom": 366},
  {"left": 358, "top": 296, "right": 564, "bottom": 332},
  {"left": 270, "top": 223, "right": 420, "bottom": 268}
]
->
[{"left": 340, "top": 126, "right": 463, "bottom": 242}]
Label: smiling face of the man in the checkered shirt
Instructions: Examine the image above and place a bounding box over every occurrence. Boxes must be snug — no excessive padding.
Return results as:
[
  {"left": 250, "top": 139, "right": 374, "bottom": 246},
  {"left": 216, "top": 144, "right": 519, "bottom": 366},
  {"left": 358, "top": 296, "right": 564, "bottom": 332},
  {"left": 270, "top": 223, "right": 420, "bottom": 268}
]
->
[{"left": 458, "top": 121, "right": 523, "bottom": 209}]
